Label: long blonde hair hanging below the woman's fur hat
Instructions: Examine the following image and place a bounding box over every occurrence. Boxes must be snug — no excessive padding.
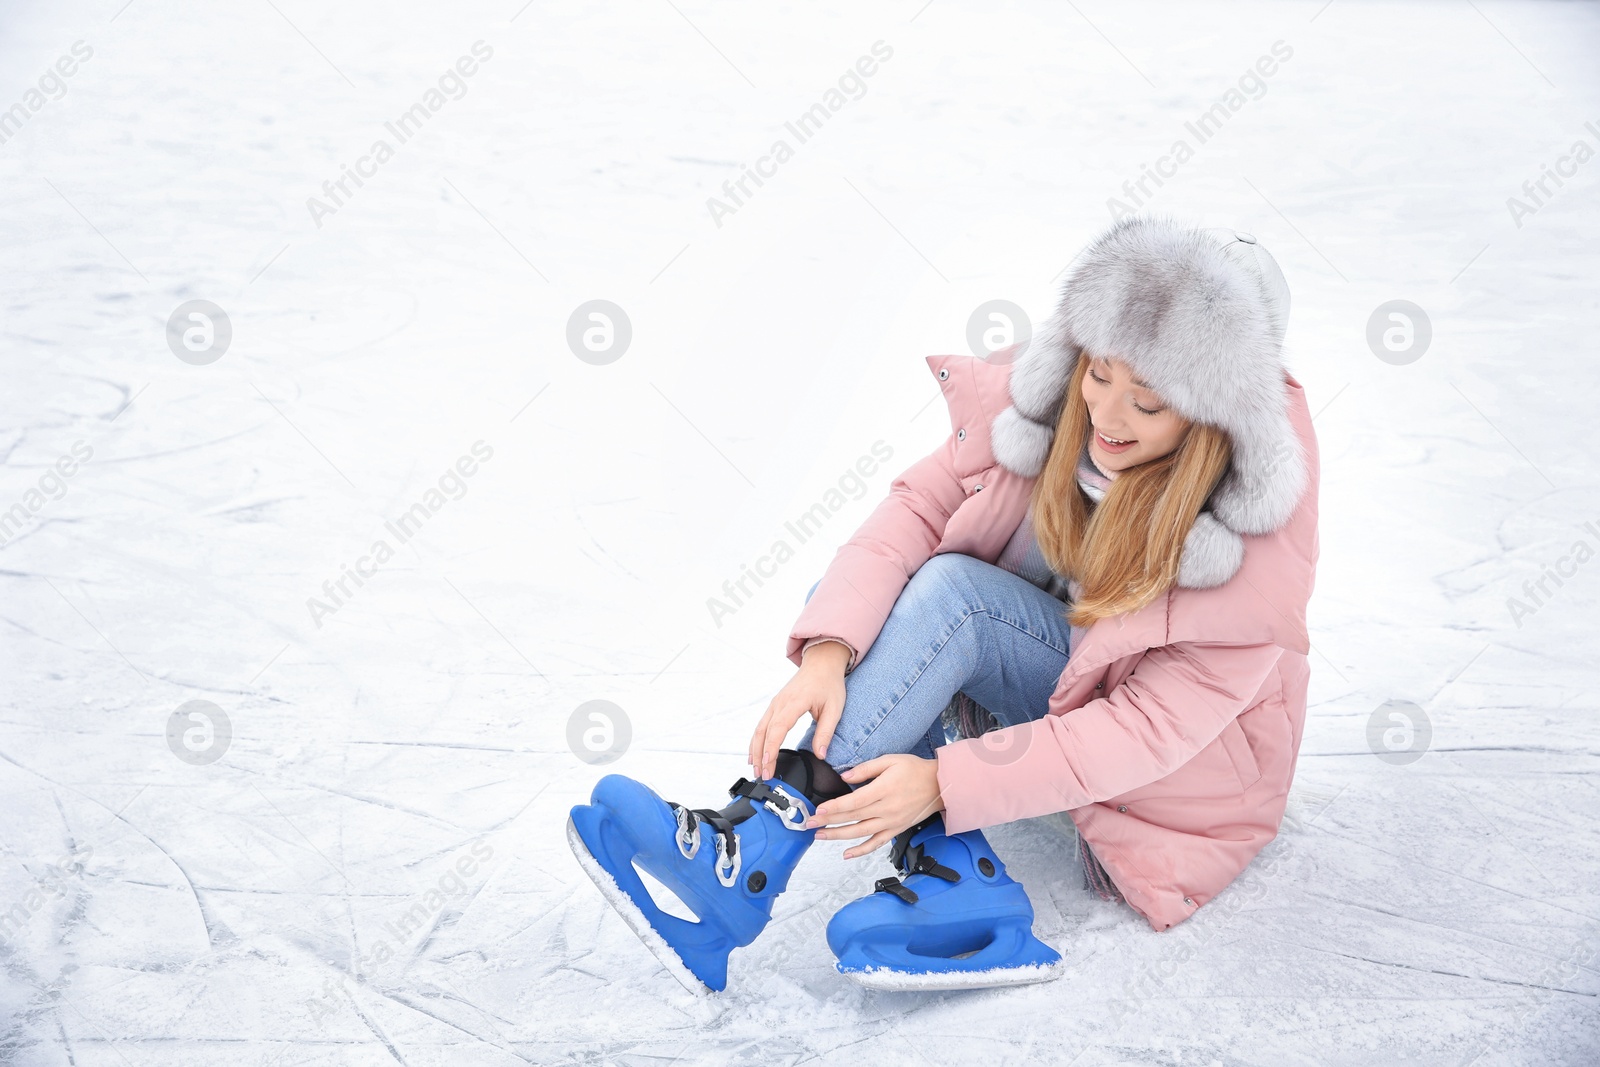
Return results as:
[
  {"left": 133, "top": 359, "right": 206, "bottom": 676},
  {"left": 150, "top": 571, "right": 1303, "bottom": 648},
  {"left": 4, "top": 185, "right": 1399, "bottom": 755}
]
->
[{"left": 1034, "top": 354, "right": 1234, "bottom": 625}]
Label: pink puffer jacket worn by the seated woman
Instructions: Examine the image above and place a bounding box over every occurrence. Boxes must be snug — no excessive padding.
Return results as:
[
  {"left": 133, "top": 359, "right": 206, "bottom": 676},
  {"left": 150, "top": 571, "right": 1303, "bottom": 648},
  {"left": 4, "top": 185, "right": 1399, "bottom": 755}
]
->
[{"left": 789, "top": 355, "right": 1318, "bottom": 931}]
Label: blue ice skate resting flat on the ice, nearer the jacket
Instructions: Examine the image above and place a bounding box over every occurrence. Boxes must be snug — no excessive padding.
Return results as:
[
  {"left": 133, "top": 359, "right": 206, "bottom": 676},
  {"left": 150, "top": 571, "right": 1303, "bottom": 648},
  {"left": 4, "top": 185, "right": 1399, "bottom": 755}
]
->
[{"left": 827, "top": 816, "right": 1062, "bottom": 990}]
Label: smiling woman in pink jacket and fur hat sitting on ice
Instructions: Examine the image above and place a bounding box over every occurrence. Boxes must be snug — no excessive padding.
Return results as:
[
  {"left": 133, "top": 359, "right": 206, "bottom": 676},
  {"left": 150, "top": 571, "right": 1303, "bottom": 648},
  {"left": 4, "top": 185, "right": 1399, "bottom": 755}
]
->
[{"left": 570, "top": 218, "right": 1318, "bottom": 989}]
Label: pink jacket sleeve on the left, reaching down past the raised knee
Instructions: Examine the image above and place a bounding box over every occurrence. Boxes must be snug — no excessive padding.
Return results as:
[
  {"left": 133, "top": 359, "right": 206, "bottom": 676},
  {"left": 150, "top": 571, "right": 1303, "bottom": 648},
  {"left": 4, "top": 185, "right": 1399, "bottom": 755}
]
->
[{"left": 787, "top": 434, "right": 966, "bottom": 665}]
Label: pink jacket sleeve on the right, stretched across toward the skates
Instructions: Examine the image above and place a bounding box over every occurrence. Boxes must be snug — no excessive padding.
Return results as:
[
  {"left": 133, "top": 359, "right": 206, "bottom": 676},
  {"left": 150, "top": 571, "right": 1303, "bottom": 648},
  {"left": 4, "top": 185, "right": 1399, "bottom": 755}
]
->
[{"left": 936, "top": 641, "right": 1283, "bottom": 833}]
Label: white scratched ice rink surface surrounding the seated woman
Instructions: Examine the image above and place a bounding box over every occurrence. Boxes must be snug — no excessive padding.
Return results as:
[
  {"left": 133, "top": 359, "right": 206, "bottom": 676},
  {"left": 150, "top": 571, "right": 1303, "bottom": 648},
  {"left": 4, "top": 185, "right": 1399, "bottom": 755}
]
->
[{"left": 0, "top": 0, "right": 1600, "bottom": 1065}]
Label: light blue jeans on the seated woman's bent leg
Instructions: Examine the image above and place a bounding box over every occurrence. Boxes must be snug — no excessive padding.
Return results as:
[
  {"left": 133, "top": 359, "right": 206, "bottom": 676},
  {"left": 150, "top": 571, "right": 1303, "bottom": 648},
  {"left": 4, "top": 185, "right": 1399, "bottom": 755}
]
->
[{"left": 798, "top": 553, "right": 1070, "bottom": 769}]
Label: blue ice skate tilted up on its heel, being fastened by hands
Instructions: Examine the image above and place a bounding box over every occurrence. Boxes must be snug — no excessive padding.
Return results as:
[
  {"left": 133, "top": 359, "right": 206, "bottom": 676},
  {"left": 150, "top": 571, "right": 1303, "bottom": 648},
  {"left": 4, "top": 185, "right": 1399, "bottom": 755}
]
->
[{"left": 566, "top": 749, "right": 850, "bottom": 992}]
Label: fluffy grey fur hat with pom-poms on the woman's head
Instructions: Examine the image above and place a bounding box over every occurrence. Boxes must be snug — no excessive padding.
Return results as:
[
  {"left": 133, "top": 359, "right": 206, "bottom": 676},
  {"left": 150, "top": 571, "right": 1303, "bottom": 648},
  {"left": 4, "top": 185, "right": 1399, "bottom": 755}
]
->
[{"left": 990, "top": 216, "right": 1306, "bottom": 589}]
